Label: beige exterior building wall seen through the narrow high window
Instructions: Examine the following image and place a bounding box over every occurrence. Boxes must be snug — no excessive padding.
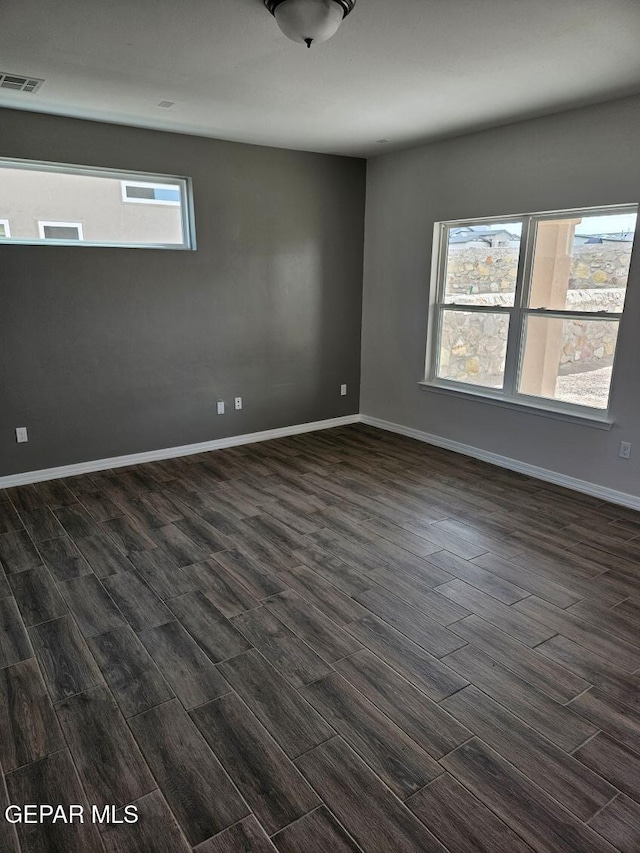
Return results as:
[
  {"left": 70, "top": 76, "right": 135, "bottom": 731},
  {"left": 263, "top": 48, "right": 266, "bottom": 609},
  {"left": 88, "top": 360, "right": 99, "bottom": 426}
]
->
[{"left": 0, "top": 168, "right": 183, "bottom": 244}]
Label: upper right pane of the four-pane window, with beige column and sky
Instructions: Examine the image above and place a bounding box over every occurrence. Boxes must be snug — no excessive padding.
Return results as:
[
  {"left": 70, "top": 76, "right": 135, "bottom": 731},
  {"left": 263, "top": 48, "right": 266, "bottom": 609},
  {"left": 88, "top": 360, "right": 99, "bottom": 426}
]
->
[{"left": 529, "top": 213, "right": 636, "bottom": 313}]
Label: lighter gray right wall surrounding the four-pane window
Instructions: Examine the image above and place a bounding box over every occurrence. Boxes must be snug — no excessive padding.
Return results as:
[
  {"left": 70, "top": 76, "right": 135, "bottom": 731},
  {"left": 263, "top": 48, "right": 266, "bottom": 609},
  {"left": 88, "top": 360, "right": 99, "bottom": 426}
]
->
[{"left": 361, "top": 98, "right": 640, "bottom": 496}]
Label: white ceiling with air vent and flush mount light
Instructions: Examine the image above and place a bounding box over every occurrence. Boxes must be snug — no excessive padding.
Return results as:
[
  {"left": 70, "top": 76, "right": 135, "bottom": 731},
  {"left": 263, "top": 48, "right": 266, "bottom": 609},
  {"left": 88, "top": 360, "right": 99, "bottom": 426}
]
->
[{"left": 0, "top": 0, "right": 640, "bottom": 156}]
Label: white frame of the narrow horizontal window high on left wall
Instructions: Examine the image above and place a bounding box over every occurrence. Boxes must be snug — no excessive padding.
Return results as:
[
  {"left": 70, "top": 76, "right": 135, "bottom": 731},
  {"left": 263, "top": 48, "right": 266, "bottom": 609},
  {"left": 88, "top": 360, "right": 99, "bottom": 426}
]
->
[{"left": 0, "top": 157, "right": 197, "bottom": 252}]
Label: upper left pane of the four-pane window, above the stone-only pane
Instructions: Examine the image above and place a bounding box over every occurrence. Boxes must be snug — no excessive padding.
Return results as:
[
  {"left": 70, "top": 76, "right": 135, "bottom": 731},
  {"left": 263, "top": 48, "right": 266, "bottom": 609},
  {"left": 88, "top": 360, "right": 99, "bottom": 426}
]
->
[{"left": 444, "top": 222, "right": 522, "bottom": 307}]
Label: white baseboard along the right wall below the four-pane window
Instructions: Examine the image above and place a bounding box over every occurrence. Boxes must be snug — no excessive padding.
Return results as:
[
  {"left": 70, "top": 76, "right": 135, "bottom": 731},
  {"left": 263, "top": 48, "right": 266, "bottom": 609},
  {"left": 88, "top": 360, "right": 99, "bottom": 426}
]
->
[{"left": 361, "top": 415, "right": 640, "bottom": 510}]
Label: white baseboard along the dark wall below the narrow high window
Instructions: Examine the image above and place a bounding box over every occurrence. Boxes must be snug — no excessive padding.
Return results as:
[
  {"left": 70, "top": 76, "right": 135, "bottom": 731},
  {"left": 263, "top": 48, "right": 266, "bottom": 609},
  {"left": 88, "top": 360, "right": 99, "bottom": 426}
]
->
[{"left": 0, "top": 415, "right": 360, "bottom": 489}]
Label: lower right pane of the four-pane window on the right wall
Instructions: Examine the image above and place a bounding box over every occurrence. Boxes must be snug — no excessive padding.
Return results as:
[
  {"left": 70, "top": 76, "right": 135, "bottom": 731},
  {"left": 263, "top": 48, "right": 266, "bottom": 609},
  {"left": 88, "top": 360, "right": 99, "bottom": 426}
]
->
[{"left": 518, "top": 316, "right": 618, "bottom": 409}]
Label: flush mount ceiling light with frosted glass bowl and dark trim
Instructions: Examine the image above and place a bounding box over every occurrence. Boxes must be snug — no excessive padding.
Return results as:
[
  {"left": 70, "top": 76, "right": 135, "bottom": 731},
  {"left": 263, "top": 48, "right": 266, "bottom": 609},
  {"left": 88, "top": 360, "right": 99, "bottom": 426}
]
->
[{"left": 264, "top": 0, "right": 356, "bottom": 47}]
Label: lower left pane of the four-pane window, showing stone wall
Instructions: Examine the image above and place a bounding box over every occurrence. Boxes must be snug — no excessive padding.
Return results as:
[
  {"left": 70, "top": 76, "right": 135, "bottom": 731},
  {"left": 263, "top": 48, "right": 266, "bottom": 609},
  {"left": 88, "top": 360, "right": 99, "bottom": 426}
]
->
[{"left": 438, "top": 309, "right": 509, "bottom": 388}]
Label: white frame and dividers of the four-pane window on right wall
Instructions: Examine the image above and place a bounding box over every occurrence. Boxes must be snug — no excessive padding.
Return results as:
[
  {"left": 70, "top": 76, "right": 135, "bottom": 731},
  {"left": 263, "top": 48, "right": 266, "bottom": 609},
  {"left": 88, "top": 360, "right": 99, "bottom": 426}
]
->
[{"left": 420, "top": 202, "right": 640, "bottom": 424}]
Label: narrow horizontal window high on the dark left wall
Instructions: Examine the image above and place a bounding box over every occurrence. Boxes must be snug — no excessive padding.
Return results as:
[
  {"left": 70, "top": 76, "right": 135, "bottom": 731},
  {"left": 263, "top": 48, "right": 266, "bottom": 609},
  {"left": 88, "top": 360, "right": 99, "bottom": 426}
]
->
[{"left": 0, "top": 159, "right": 195, "bottom": 249}]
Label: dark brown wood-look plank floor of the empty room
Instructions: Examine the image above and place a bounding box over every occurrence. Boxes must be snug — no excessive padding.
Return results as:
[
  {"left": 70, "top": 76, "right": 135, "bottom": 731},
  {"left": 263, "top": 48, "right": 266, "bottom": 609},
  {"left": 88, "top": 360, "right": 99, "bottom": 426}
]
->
[{"left": 0, "top": 425, "right": 640, "bottom": 853}]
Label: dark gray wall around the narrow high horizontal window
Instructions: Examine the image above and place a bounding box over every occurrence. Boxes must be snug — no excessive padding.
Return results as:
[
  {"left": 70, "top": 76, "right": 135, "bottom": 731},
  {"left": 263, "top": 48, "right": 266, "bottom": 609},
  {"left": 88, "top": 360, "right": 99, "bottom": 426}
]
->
[{"left": 0, "top": 110, "right": 366, "bottom": 476}]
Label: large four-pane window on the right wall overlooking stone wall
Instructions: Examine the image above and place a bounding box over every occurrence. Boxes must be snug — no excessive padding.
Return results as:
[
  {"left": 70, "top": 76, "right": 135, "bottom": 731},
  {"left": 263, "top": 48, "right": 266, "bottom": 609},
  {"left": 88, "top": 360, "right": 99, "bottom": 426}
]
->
[{"left": 426, "top": 205, "right": 638, "bottom": 417}]
